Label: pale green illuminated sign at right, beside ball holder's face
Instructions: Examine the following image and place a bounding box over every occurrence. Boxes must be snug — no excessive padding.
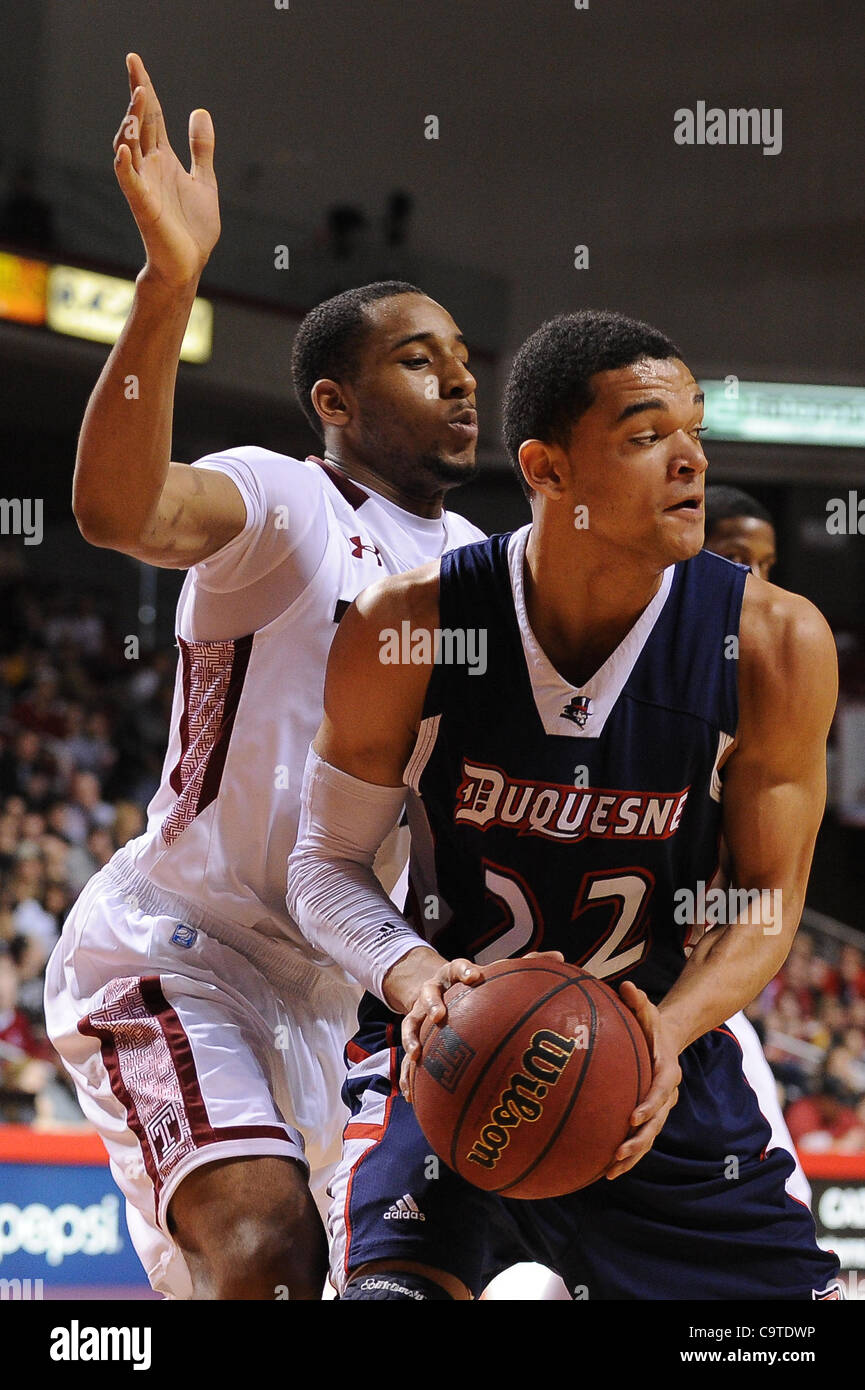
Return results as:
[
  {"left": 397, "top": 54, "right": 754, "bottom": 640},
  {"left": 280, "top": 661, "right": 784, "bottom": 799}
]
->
[{"left": 701, "top": 377, "right": 865, "bottom": 449}]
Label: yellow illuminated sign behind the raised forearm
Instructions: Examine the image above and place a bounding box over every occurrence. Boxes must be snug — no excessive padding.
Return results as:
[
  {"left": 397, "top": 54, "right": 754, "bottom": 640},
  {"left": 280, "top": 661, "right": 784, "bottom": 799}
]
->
[{"left": 46, "top": 265, "right": 213, "bottom": 361}]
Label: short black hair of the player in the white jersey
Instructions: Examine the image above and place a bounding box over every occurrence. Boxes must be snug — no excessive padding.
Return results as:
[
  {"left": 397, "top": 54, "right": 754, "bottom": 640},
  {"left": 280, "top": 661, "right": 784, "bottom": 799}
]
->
[{"left": 291, "top": 279, "right": 424, "bottom": 435}]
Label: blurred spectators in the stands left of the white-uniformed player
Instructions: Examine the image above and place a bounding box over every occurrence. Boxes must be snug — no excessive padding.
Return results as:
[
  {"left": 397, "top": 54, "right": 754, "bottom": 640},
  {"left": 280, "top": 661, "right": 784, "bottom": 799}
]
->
[{"left": 0, "top": 580, "right": 174, "bottom": 1123}]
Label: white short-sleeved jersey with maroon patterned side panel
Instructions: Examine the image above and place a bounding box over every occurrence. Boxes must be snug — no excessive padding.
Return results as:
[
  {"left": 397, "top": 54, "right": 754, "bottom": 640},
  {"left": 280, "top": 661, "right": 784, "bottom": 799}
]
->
[{"left": 113, "top": 448, "right": 483, "bottom": 960}]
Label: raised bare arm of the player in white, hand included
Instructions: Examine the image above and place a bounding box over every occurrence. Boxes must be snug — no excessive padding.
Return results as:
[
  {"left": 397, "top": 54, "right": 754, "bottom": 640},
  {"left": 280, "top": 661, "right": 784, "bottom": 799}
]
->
[{"left": 72, "top": 53, "right": 246, "bottom": 569}]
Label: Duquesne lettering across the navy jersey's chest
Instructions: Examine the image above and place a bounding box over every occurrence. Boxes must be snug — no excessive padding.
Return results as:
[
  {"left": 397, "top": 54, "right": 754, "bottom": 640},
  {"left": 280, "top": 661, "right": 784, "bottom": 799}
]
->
[{"left": 453, "top": 758, "right": 691, "bottom": 840}]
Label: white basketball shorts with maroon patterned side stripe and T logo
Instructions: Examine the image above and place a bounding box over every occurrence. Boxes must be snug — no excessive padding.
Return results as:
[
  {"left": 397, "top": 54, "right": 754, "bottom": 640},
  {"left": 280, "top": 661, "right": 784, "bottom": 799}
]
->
[{"left": 46, "top": 870, "right": 357, "bottom": 1298}]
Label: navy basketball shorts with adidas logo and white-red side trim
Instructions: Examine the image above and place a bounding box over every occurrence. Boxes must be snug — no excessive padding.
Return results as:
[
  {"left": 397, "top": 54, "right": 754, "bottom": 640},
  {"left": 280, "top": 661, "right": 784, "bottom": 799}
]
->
[{"left": 328, "top": 997, "right": 839, "bottom": 1300}]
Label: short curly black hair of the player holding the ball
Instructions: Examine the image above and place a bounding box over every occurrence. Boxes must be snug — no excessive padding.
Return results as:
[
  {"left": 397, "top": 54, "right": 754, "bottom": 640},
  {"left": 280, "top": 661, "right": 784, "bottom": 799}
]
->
[{"left": 502, "top": 309, "right": 681, "bottom": 491}]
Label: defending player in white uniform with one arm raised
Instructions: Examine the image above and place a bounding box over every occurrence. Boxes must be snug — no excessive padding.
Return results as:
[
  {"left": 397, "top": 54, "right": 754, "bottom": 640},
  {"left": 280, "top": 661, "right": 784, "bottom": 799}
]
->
[{"left": 46, "top": 54, "right": 481, "bottom": 1300}]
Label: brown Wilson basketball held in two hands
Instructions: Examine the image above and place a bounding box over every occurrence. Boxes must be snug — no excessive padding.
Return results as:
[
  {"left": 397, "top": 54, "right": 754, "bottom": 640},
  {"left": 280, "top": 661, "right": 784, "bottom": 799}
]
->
[{"left": 412, "top": 958, "right": 652, "bottom": 1200}]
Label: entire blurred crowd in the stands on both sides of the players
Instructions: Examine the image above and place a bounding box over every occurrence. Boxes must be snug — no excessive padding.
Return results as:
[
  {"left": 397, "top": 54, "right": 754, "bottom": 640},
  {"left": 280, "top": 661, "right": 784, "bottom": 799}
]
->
[{"left": 0, "top": 569, "right": 865, "bottom": 1152}]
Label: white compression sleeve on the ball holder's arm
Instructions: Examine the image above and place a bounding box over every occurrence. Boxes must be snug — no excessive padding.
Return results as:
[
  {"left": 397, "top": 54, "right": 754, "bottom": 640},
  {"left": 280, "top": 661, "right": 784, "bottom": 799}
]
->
[{"left": 285, "top": 748, "right": 428, "bottom": 1002}]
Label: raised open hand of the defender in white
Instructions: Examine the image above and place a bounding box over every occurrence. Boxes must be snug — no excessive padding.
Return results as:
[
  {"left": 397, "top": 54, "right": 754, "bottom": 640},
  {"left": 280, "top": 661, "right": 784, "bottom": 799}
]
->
[{"left": 114, "top": 53, "right": 220, "bottom": 288}]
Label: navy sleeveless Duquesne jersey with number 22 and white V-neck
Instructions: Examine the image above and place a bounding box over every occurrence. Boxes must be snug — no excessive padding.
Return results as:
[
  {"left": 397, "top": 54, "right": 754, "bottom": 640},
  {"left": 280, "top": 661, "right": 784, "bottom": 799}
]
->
[{"left": 405, "top": 527, "right": 747, "bottom": 1001}]
